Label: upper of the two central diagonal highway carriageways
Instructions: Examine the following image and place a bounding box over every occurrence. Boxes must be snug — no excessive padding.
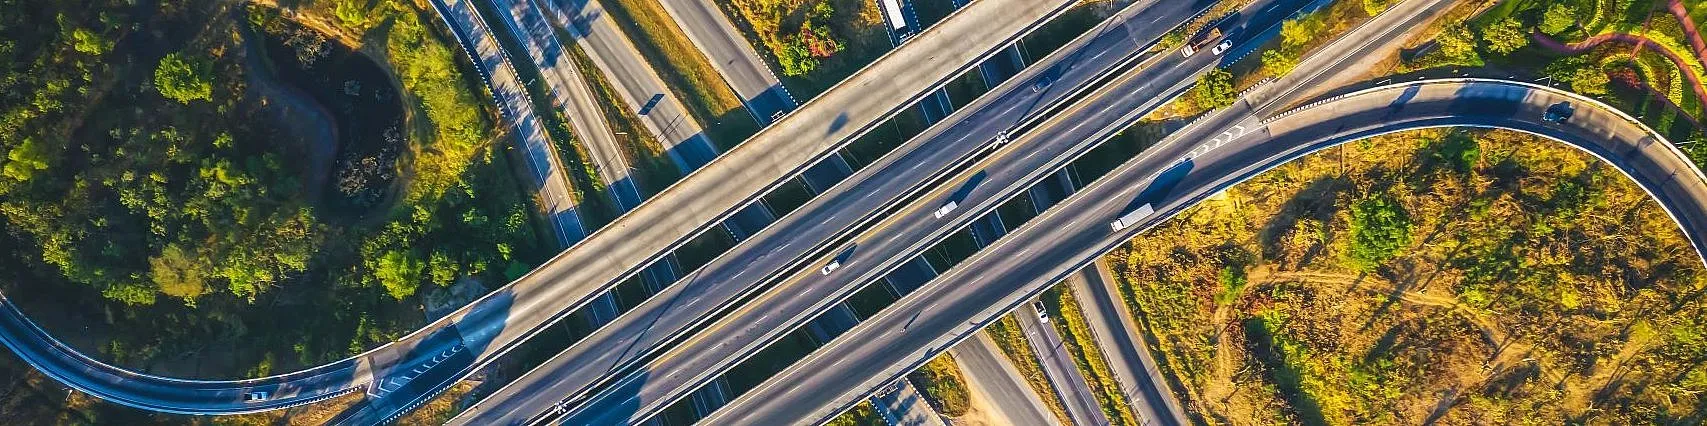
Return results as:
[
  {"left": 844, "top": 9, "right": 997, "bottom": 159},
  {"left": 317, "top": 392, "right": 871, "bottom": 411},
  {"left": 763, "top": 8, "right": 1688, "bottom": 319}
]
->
[{"left": 452, "top": 2, "right": 1212, "bottom": 424}]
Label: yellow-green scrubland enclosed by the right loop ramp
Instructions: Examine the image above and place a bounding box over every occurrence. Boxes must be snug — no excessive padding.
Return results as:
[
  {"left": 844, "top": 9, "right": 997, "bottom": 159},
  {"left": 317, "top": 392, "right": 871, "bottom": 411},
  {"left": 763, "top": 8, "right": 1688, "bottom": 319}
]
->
[{"left": 1111, "top": 130, "right": 1707, "bottom": 424}]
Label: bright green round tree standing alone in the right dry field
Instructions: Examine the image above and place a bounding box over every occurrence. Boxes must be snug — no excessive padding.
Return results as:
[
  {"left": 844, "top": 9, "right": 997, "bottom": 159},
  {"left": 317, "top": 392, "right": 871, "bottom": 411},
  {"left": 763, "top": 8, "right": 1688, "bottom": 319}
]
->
[{"left": 1347, "top": 194, "right": 1412, "bottom": 271}]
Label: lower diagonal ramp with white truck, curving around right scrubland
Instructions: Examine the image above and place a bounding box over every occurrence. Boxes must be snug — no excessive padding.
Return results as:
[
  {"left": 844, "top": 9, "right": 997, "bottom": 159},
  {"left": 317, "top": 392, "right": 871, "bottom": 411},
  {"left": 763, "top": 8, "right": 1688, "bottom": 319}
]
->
[{"left": 705, "top": 75, "right": 1707, "bottom": 424}]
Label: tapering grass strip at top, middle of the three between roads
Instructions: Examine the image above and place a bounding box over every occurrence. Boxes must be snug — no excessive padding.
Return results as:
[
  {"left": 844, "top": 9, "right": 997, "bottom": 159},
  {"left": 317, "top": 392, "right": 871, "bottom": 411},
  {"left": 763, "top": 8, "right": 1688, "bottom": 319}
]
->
[{"left": 568, "top": 44, "right": 683, "bottom": 198}]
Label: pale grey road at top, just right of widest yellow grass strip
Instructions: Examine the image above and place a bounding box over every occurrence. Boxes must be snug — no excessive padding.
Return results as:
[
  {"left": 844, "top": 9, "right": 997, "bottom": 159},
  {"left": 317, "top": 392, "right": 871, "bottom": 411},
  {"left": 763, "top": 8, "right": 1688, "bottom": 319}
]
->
[{"left": 659, "top": 0, "right": 795, "bottom": 124}]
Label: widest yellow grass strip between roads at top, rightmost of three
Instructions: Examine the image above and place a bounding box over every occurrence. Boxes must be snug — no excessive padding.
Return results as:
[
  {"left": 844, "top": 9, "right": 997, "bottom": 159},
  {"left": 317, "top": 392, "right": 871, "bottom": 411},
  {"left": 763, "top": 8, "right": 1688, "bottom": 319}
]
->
[{"left": 587, "top": 0, "right": 760, "bottom": 150}]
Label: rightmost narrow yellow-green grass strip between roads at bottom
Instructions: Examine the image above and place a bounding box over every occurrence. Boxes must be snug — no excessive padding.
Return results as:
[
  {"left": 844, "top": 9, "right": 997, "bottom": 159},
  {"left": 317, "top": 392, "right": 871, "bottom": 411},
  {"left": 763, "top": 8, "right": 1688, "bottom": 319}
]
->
[{"left": 1043, "top": 285, "right": 1140, "bottom": 426}]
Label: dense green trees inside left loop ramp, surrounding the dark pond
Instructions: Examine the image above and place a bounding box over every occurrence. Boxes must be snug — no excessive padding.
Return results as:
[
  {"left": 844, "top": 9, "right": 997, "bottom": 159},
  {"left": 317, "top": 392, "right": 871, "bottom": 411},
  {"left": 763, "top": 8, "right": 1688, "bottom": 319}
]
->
[{"left": 0, "top": 0, "right": 546, "bottom": 391}]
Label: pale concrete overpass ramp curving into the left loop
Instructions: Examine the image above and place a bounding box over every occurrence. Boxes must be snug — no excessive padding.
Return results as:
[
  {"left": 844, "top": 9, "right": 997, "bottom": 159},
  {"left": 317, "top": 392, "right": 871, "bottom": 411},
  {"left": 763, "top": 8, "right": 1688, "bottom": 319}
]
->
[{"left": 0, "top": 0, "right": 1072, "bottom": 419}]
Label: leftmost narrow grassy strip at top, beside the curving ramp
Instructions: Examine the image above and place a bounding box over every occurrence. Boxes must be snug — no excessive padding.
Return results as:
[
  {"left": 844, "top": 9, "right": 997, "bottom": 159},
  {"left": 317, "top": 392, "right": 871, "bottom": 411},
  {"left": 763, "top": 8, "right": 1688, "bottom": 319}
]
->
[{"left": 475, "top": 2, "right": 616, "bottom": 226}]
